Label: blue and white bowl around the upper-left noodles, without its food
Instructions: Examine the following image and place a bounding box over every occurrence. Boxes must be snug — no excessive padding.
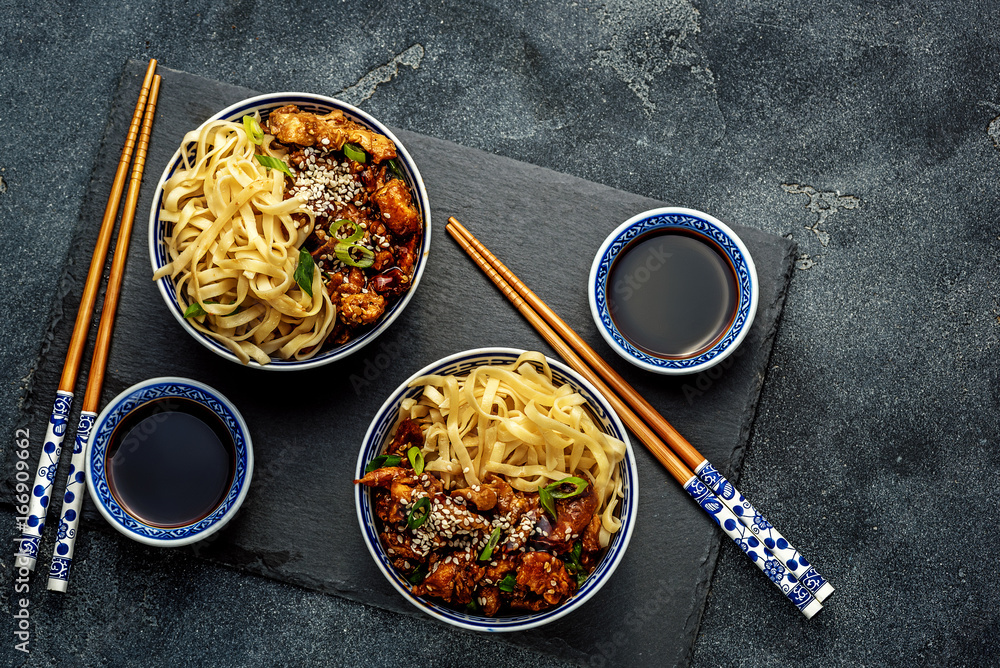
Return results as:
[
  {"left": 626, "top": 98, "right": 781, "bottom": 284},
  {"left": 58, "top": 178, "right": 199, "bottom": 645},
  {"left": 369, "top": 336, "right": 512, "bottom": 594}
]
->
[{"left": 149, "top": 93, "right": 431, "bottom": 371}]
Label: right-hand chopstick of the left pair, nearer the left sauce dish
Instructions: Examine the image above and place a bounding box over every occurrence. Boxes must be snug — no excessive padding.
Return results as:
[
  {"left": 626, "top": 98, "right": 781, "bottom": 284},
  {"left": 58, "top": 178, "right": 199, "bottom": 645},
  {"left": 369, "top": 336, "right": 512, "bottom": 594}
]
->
[{"left": 48, "top": 75, "right": 160, "bottom": 592}]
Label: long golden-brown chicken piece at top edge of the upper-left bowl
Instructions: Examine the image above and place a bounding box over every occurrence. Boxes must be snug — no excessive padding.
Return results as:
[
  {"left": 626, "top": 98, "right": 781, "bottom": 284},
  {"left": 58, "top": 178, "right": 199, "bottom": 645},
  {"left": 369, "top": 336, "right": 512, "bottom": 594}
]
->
[{"left": 267, "top": 104, "right": 396, "bottom": 162}]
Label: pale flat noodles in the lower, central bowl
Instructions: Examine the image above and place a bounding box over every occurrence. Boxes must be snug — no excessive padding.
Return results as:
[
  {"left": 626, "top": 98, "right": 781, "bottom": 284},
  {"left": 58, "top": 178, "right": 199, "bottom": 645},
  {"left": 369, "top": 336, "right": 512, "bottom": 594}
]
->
[{"left": 399, "top": 352, "right": 625, "bottom": 546}]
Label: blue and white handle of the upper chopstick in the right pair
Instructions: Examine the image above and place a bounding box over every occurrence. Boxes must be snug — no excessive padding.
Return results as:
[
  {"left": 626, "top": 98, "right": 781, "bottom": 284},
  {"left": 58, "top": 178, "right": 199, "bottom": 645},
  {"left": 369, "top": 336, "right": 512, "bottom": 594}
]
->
[{"left": 695, "top": 460, "right": 833, "bottom": 603}]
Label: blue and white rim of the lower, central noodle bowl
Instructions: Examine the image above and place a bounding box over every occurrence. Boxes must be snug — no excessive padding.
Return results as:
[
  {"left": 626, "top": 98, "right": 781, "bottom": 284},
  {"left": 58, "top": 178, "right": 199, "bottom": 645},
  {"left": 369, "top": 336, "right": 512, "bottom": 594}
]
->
[{"left": 354, "top": 347, "right": 639, "bottom": 632}]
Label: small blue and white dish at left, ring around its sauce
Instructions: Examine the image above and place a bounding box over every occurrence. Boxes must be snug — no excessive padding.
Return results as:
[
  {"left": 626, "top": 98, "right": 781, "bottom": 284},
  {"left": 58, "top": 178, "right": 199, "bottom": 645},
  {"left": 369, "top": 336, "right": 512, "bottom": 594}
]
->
[{"left": 86, "top": 377, "right": 253, "bottom": 547}]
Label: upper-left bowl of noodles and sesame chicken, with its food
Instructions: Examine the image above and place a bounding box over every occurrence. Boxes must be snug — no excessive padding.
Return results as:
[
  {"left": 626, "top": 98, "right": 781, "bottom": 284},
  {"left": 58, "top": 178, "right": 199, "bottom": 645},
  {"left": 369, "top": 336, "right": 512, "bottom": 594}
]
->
[{"left": 150, "top": 94, "right": 430, "bottom": 368}]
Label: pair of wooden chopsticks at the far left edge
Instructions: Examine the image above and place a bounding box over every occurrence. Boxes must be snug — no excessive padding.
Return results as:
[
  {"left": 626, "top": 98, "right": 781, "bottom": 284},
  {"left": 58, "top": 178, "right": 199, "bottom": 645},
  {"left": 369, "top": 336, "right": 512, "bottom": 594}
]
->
[{"left": 15, "top": 59, "right": 160, "bottom": 591}]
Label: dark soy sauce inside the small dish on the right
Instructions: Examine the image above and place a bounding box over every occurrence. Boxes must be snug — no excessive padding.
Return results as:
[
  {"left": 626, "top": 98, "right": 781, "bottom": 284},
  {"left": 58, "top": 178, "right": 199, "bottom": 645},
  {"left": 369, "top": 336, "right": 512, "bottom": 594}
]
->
[{"left": 607, "top": 231, "right": 739, "bottom": 358}]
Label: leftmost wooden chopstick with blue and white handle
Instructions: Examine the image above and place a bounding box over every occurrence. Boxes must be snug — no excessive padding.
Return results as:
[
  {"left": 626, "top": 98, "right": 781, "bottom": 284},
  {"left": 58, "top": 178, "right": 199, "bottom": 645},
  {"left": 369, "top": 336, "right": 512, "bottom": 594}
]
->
[{"left": 14, "top": 59, "right": 156, "bottom": 570}]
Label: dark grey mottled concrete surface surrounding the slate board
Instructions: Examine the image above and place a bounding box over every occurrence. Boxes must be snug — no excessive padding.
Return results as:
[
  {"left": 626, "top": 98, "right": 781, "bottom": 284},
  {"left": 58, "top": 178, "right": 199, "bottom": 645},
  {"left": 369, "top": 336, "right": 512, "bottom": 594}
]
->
[{"left": 0, "top": 0, "right": 1000, "bottom": 666}]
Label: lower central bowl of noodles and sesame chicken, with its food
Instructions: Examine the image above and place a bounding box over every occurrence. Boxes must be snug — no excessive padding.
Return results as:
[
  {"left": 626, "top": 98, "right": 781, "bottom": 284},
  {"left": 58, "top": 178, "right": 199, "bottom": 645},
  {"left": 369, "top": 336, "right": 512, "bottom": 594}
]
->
[{"left": 355, "top": 349, "right": 636, "bottom": 630}]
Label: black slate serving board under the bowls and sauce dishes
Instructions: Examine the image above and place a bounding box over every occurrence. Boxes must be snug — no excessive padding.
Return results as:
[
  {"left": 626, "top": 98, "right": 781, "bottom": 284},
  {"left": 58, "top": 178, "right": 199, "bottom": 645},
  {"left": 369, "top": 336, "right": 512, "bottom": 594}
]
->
[{"left": 2, "top": 62, "right": 794, "bottom": 665}]
